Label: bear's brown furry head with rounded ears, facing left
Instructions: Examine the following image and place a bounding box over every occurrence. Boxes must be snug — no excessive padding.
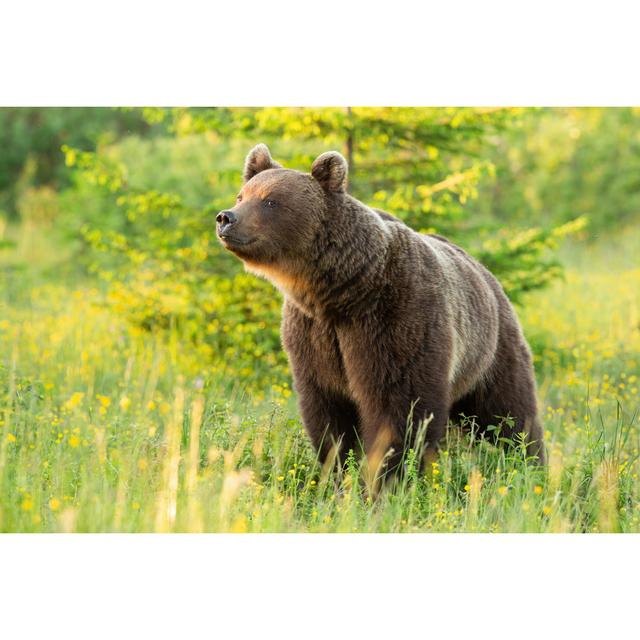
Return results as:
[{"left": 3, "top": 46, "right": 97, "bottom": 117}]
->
[{"left": 216, "top": 144, "right": 347, "bottom": 274}]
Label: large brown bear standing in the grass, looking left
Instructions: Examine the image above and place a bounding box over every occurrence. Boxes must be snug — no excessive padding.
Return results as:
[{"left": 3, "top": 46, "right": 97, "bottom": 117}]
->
[{"left": 216, "top": 144, "right": 544, "bottom": 470}]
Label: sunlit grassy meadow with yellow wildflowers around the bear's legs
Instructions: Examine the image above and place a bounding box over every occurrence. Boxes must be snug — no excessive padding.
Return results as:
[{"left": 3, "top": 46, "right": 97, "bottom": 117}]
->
[{"left": 0, "top": 218, "right": 640, "bottom": 532}]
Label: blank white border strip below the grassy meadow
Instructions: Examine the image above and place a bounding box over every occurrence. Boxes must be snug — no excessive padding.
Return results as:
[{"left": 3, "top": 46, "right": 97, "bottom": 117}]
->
[{"left": 0, "top": 534, "right": 640, "bottom": 640}]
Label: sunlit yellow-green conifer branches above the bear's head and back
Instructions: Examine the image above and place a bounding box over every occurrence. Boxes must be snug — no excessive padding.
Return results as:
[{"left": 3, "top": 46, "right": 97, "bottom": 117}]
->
[{"left": 166, "top": 107, "right": 586, "bottom": 301}]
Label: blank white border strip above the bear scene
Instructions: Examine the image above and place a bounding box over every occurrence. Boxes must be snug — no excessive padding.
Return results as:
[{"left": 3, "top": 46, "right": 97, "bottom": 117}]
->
[{"left": 0, "top": 0, "right": 640, "bottom": 106}]
